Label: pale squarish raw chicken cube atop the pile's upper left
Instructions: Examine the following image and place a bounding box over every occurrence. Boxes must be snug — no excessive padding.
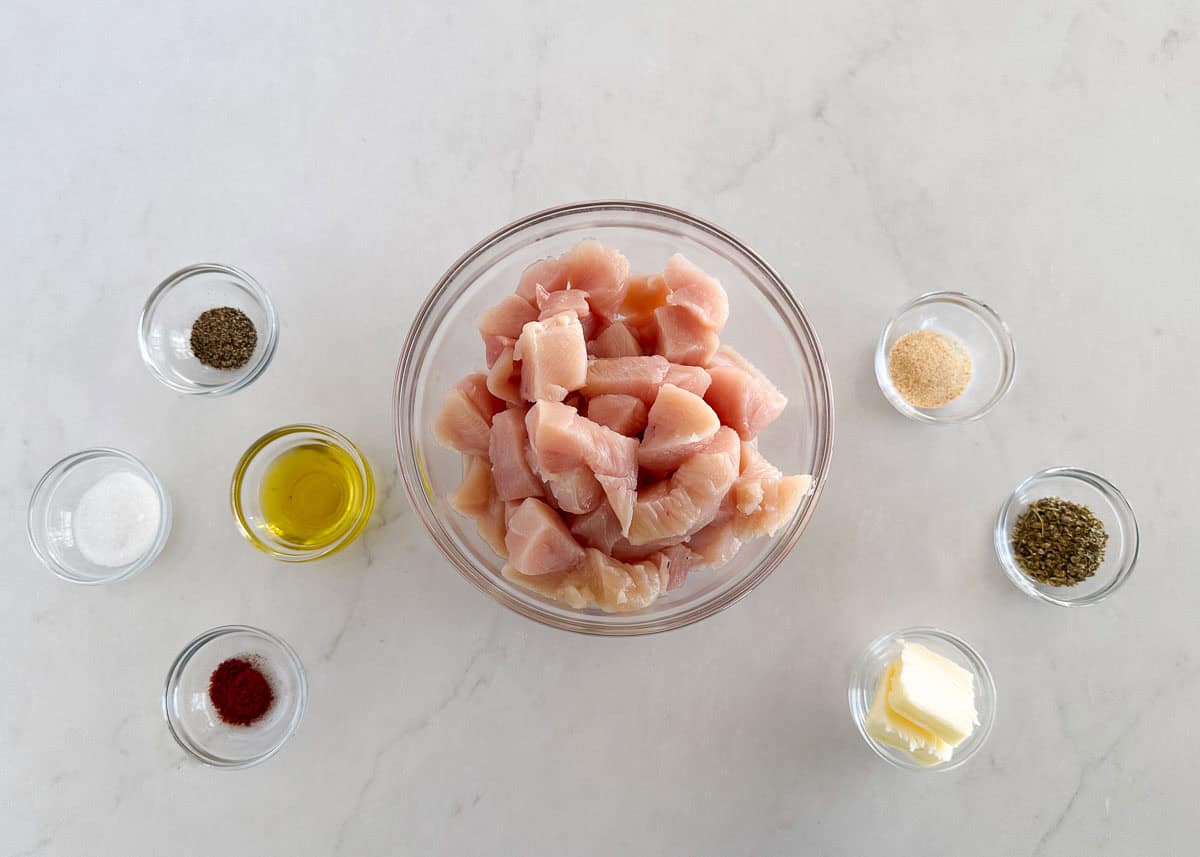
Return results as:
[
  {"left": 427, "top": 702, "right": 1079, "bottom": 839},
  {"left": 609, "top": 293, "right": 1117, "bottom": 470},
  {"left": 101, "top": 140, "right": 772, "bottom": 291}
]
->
[{"left": 512, "top": 312, "right": 588, "bottom": 402}]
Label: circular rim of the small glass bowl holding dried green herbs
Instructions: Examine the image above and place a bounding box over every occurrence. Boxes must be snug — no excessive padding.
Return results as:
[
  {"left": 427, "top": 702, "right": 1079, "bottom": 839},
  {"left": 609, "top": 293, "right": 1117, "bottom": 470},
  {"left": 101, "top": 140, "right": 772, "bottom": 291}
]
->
[{"left": 992, "top": 466, "right": 1141, "bottom": 607}]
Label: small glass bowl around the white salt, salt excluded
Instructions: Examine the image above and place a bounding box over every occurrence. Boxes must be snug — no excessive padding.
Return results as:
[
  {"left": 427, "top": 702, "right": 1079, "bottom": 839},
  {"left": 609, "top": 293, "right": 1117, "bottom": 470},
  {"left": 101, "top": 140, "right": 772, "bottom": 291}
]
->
[{"left": 29, "top": 448, "right": 170, "bottom": 585}]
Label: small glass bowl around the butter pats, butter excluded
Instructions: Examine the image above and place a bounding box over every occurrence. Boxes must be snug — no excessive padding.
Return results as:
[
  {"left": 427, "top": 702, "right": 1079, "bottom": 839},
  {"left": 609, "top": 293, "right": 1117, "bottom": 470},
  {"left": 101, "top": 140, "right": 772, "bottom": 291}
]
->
[{"left": 850, "top": 627, "right": 996, "bottom": 771}]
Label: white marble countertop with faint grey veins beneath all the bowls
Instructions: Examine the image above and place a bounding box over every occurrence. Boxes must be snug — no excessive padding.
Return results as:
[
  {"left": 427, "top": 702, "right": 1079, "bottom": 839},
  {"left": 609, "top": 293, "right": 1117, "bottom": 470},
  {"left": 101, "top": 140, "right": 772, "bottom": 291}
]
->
[{"left": 0, "top": 0, "right": 1200, "bottom": 857}]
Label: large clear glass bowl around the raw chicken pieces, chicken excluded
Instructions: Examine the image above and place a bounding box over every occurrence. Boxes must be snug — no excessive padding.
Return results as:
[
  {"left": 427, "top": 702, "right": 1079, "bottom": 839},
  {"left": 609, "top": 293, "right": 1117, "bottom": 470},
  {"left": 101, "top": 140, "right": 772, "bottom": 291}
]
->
[{"left": 394, "top": 200, "right": 834, "bottom": 635}]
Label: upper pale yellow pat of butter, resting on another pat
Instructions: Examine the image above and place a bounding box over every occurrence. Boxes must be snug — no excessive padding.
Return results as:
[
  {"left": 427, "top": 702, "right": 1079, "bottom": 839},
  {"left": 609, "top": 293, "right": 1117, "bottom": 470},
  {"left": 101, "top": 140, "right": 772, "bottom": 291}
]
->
[{"left": 888, "top": 641, "right": 979, "bottom": 747}]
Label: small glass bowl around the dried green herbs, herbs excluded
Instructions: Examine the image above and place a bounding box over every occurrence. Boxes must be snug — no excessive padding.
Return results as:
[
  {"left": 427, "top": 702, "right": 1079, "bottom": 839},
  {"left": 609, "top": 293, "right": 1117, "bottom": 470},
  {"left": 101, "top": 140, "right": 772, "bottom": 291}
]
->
[{"left": 992, "top": 467, "right": 1139, "bottom": 607}]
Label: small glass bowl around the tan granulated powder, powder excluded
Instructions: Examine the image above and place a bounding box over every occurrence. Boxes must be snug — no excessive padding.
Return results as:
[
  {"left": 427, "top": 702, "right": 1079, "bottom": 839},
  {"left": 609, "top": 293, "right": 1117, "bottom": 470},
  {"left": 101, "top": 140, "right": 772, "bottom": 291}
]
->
[{"left": 875, "top": 292, "right": 1016, "bottom": 424}]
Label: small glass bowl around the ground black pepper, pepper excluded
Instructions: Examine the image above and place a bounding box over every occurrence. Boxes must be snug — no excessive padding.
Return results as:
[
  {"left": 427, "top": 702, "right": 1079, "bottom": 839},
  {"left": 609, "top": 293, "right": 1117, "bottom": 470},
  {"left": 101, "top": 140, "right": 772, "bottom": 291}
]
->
[{"left": 138, "top": 263, "right": 280, "bottom": 396}]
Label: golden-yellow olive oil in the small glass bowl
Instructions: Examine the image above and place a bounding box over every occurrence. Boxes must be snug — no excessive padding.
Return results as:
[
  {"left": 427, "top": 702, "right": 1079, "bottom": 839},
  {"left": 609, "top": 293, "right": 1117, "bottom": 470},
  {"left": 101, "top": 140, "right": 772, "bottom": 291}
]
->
[{"left": 259, "top": 442, "right": 364, "bottom": 547}]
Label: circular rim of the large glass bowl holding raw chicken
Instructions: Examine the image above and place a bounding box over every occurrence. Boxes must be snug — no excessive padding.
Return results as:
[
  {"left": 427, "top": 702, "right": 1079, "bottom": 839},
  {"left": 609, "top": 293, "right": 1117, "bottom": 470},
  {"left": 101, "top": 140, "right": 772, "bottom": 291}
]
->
[{"left": 392, "top": 199, "right": 836, "bottom": 636}]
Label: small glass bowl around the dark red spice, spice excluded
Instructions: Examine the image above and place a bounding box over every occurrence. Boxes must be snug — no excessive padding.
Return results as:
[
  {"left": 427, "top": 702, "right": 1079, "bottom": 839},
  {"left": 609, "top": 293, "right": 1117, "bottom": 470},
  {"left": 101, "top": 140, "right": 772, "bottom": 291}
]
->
[{"left": 162, "top": 625, "right": 307, "bottom": 768}]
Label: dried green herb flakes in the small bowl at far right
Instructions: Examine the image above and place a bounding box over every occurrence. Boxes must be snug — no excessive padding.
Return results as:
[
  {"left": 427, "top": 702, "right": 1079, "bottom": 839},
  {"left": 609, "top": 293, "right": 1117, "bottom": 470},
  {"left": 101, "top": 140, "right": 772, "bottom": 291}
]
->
[{"left": 1012, "top": 497, "right": 1109, "bottom": 586}]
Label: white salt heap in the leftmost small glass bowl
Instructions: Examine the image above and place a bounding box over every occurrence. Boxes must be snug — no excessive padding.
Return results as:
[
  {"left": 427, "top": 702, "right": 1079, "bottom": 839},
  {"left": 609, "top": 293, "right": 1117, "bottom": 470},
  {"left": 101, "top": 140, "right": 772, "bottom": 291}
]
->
[{"left": 72, "top": 473, "right": 162, "bottom": 568}]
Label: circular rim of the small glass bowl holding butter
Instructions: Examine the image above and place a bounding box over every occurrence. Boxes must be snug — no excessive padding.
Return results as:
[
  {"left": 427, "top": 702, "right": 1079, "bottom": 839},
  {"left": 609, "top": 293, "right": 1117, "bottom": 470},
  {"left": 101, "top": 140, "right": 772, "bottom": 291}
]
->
[{"left": 847, "top": 625, "right": 1000, "bottom": 773}]
